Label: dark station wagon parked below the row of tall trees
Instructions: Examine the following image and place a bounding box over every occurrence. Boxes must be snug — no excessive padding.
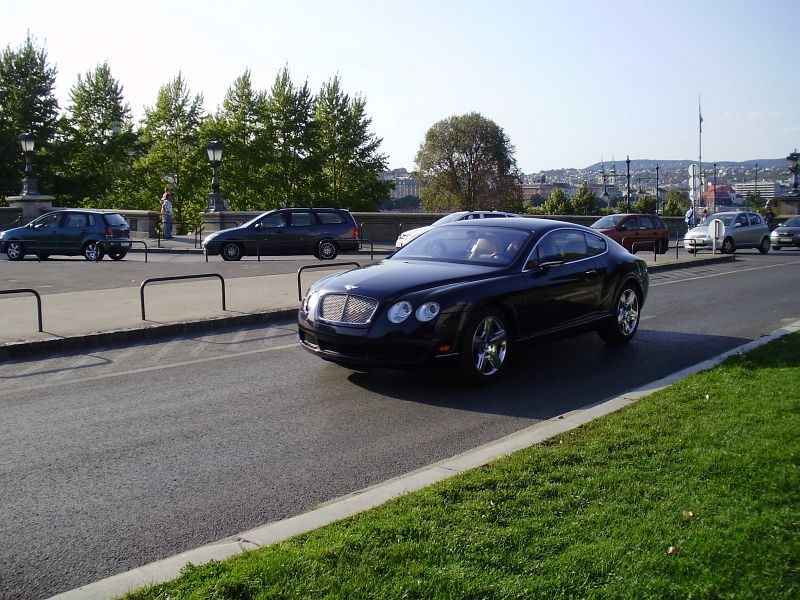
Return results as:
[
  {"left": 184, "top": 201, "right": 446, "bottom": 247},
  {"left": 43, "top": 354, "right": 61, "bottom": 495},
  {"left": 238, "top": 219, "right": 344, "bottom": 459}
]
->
[{"left": 203, "top": 208, "right": 359, "bottom": 260}]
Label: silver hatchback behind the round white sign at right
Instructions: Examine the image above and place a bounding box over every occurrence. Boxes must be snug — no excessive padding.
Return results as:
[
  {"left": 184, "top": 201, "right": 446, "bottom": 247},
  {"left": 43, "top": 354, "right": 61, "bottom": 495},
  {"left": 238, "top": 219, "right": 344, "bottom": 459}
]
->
[{"left": 683, "top": 211, "right": 770, "bottom": 254}]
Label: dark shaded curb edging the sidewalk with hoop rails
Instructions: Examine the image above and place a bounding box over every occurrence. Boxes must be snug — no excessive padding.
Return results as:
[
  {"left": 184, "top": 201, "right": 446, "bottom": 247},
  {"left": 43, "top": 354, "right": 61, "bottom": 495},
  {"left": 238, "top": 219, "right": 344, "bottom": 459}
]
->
[{"left": 0, "top": 308, "right": 297, "bottom": 359}]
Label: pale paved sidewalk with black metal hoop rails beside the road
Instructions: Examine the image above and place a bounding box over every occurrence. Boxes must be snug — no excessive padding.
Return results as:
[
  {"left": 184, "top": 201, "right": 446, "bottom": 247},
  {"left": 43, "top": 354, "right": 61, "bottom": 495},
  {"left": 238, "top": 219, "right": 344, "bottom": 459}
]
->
[{"left": 0, "top": 236, "right": 734, "bottom": 359}]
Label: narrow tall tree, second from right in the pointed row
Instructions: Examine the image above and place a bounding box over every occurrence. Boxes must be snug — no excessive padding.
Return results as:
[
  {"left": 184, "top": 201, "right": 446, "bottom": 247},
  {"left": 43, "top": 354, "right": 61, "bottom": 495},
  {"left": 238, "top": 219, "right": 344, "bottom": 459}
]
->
[{"left": 265, "top": 67, "right": 320, "bottom": 206}]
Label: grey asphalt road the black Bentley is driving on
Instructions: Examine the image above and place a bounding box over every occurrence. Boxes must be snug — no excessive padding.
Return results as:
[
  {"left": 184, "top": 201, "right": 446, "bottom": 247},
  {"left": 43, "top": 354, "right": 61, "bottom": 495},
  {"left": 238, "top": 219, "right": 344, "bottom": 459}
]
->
[{"left": 0, "top": 251, "right": 800, "bottom": 598}]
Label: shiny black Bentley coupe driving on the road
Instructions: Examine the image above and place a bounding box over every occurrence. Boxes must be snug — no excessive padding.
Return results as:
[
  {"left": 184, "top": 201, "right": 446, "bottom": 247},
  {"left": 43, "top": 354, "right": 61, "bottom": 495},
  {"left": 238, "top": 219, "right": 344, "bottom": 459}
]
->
[{"left": 298, "top": 217, "right": 648, "bottom": 383}]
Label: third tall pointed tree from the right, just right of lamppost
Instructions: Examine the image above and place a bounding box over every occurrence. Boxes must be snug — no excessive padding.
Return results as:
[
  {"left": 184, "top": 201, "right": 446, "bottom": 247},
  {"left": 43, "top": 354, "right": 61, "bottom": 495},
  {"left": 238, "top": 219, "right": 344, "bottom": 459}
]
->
[{"left": 200, "top": 71, "right": 274, "bottom": 210}]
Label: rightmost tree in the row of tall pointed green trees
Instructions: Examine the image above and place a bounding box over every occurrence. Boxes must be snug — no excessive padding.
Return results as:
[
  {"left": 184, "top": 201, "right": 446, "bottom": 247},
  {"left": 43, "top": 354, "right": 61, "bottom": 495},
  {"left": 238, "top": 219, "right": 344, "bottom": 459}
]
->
[{"left": 314, "top": 77, "right": 390, "bottom": 211}]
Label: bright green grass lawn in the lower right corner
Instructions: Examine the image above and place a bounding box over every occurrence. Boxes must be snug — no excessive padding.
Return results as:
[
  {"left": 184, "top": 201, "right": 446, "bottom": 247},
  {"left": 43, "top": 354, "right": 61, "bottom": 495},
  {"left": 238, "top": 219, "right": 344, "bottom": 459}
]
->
[{"left": 126, "top": 334, "right": 800, "bottom": 600}]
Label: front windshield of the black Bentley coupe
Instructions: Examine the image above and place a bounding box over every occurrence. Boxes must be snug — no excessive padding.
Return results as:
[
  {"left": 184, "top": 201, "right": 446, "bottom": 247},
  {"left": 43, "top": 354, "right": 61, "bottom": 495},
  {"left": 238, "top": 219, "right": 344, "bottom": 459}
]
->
[{"left": 392, "top": 226, "right": 530, "bottom": 266}]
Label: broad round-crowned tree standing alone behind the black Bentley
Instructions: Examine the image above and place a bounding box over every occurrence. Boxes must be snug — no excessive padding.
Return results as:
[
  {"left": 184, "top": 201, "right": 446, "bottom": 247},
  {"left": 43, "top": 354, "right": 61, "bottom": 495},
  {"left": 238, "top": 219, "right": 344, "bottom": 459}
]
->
[{"left": 416, "top": 112, "right": 522, "bottom": 211}]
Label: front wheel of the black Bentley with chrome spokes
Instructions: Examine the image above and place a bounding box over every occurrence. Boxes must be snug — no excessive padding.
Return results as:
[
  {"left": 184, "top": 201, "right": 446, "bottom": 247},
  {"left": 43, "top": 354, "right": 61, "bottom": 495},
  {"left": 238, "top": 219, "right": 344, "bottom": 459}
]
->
[{"left": 459, "top": 309, "right": 510, "bottom": 385}]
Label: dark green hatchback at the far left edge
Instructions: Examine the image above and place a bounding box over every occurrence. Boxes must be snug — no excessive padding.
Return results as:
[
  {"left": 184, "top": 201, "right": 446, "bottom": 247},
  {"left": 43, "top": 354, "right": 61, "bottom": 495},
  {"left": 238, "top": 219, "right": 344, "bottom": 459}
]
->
[{"left": 0, "top": 209, "right": 131, "bottom": 260}]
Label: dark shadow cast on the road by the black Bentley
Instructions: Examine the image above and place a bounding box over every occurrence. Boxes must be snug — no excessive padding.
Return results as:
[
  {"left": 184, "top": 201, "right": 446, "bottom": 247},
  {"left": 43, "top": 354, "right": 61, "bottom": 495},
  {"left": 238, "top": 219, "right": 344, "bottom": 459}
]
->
[{"left": 347, "top": 330, "right": 750, "bottom": 419}]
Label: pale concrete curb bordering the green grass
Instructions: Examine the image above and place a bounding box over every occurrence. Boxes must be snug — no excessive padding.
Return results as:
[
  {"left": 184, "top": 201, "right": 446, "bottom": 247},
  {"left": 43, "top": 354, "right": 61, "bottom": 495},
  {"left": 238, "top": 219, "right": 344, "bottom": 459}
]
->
[{"left": 48, "top": 320, "right": 800, "bottom": 600}]
